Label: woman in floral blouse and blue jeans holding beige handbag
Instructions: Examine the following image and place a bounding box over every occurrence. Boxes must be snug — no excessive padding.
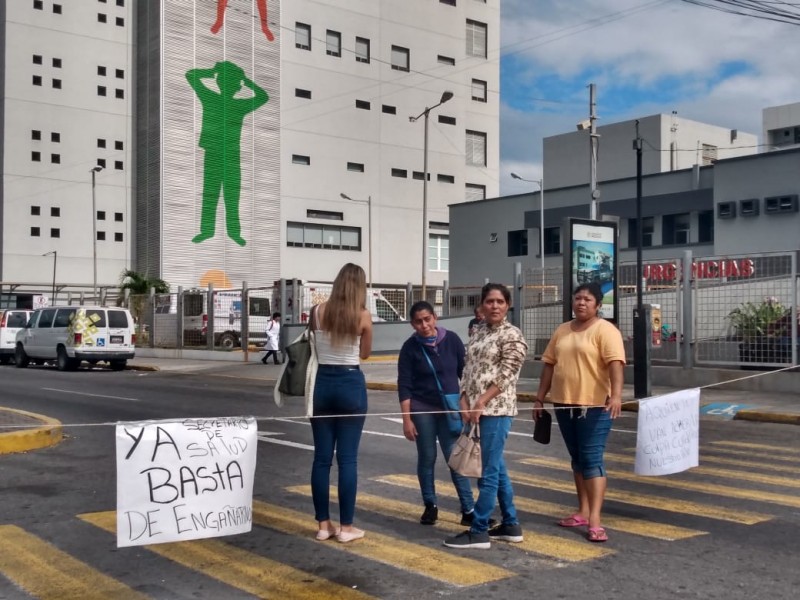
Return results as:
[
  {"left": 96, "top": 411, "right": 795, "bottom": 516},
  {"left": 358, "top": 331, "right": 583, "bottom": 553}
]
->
[{"left": 444, "top": 283, "right": 528, "bottom": 549}]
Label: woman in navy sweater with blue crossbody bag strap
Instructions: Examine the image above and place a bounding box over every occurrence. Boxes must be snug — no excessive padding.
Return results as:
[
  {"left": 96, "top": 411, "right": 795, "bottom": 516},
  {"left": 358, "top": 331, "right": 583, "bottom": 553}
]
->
[{"left": 397, "top": 301, "right": 475, "bottom": 525}]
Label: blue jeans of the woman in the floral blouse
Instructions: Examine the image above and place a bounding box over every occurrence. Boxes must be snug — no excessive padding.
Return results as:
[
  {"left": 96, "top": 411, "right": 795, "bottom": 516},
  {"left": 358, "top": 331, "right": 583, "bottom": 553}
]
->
[{"left": 470, "top": 417, "right": 519, "bottom": 533}]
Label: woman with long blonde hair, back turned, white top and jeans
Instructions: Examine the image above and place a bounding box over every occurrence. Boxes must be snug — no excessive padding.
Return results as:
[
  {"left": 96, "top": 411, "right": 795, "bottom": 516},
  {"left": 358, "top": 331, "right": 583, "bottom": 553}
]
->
[{"left": 309, "top": 263, "right": 372, "bottom": 543}]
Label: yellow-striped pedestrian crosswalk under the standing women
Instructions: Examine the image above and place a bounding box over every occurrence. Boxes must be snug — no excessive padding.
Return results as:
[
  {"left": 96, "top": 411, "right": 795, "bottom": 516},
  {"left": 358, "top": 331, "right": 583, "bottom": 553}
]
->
[{"left": 0, "top": 441, "right": 800, "bottom": 600}]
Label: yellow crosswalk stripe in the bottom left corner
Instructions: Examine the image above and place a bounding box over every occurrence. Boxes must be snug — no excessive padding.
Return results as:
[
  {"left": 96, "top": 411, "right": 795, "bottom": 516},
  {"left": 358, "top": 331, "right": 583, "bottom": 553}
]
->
[{"left": 0, "top": 525, "right": 147, "bottom": 600}]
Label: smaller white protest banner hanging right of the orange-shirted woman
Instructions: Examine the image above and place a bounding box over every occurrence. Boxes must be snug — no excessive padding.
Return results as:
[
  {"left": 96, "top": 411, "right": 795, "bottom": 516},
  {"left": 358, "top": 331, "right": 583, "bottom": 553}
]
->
[{"left": 634, "top": 389, "right": 700, "bottom": 475}]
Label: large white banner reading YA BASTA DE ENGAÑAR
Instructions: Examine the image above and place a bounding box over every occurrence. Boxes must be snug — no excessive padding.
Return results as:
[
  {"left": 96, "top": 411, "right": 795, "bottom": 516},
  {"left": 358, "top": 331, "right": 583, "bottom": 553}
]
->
[{"left": 117, "top": 417, "right": 258, "bottom": 547}]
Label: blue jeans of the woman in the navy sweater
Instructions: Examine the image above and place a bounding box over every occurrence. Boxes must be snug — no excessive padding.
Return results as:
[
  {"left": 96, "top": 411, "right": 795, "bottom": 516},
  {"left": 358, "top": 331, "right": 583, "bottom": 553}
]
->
[{"left": 411, "top": 413, "right": 475, "bottom": 513}]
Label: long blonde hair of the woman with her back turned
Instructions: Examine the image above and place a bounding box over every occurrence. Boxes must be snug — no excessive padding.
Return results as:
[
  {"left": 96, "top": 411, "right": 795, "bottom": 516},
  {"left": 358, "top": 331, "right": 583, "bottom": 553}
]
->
[{"left": 319, "top": 263, "right": 367, "bottom": 347}]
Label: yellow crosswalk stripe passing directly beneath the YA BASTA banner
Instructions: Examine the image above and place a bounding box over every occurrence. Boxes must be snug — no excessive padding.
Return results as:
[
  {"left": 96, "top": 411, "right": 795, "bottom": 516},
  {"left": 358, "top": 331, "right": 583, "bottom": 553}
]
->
[{"left": 78, "top": 510, "right": 371, "bottom": 600}]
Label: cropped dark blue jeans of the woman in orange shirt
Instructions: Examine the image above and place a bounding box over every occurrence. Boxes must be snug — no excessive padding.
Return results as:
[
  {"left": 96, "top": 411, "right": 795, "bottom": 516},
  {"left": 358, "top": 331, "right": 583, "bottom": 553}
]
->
[{"left": 556, "top": 404, "right": 611, "bottom": 479}]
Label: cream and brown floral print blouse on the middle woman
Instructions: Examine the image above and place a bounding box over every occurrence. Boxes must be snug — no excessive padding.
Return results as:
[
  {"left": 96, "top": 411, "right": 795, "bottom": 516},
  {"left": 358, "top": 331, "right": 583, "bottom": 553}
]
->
[{"left": 461, "top": 319, "right": 528, "bottom": 417}]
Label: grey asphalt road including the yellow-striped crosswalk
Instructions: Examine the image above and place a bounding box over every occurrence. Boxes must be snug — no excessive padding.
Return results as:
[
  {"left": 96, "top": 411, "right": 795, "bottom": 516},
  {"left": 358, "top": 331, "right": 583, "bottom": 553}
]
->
[{"left": 0, "top": 367, "right": 800, "bottom": 599}]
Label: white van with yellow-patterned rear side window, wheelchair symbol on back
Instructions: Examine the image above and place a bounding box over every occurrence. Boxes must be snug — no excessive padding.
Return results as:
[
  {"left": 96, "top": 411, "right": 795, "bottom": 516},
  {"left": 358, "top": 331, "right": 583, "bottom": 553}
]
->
[{"left": 14, "top": 306, "right": 136, "bottom": 371}]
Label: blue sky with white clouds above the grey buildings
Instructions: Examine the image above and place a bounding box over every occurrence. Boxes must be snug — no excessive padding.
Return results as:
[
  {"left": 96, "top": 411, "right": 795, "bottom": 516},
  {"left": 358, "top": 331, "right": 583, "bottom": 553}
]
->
[{"left": 499, "top": 0, "right": 800, "bottom": 194}]
